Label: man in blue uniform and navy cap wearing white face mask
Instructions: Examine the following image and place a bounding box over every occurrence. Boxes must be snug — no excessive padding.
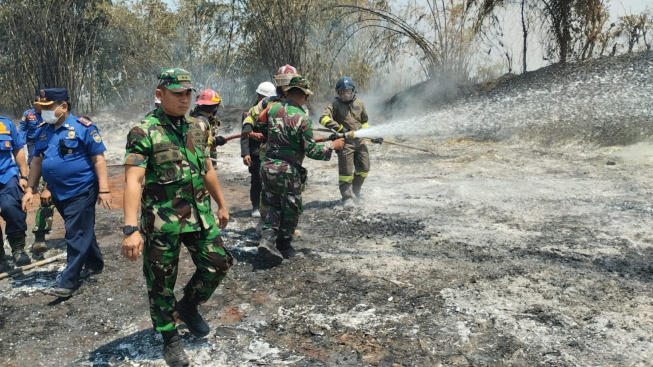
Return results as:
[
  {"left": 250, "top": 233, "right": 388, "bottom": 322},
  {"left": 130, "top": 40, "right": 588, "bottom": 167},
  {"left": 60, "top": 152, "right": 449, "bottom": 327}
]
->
[{"left": 23, "top": 88, "right": 111, "bottom": 297}]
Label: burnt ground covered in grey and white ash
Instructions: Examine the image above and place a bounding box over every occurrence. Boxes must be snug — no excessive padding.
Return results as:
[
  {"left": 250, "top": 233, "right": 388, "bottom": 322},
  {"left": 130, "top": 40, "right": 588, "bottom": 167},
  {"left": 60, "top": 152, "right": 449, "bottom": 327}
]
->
[{"left": 0, "top": 53, "right": 653, "bottom": 366}]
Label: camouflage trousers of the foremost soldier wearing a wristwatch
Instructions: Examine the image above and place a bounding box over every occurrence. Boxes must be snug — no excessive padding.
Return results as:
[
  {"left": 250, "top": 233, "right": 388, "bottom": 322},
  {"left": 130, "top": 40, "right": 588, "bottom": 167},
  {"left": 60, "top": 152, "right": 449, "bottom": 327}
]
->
[{"left": 143, "top": 226, "right": 233, "bottom": 331}]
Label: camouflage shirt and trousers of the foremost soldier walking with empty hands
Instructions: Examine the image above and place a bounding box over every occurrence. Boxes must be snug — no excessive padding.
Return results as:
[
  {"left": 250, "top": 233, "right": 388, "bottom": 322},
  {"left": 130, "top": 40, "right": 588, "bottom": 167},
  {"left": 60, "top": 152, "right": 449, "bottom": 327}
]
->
[{"left": 124, "top": 108, "right": 233, "bottom": 331}]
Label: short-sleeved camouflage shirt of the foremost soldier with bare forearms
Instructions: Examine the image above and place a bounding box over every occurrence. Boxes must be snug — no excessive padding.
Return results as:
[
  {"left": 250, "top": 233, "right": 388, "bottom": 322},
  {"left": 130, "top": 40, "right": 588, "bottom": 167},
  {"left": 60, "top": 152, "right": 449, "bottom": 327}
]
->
[{"left": 124, "top": 108, "right": 215, "bottom": 234}]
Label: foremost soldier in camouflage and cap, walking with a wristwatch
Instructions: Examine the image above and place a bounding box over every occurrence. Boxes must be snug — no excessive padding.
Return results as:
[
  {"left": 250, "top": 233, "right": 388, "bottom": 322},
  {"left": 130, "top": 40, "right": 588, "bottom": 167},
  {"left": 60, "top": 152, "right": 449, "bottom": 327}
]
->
[{"left": 122, "top": 69, "right": 233, "bottom": 365}]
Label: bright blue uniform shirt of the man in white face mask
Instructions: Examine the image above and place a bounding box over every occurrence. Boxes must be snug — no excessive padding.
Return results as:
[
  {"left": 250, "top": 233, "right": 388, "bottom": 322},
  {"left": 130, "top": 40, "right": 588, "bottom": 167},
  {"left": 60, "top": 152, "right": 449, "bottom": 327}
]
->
[{"left": 34, "top": 114, "right": 107, "bottom": 200}]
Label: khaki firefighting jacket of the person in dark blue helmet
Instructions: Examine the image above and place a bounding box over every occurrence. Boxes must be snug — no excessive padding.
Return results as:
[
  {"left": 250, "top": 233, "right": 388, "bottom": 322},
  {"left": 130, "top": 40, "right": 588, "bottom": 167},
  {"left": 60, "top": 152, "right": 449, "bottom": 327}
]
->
[{"left": 320, "top": 98, "right": 368, "bottom": 131}]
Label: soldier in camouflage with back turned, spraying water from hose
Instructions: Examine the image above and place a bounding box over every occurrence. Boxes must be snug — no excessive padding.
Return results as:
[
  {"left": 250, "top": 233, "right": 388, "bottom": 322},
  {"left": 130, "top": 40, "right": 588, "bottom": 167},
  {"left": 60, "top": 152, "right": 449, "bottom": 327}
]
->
[{"left": 258, "top": 75, "right": 344, "bottom": 262}]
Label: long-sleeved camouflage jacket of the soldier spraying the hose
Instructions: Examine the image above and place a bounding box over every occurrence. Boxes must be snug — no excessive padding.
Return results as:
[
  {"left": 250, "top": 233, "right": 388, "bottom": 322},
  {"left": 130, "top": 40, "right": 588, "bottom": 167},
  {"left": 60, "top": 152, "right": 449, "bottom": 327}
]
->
[{"left": 259, "top": 101, "right": 333, "bottom": 167}]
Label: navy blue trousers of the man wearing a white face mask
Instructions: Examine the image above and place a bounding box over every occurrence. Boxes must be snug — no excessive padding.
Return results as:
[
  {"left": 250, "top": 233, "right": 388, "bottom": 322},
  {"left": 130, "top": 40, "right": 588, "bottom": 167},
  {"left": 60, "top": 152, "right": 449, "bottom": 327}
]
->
[{"left": 52, "top": 186, "right": 104, "bottom": 289}]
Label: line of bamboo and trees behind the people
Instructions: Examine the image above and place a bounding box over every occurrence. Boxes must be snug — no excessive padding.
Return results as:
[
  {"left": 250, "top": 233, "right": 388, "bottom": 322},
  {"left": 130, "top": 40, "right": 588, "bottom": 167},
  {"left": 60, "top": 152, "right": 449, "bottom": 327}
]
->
[{"left": 0, "top": 0, "right": 653, "bottom": 114}]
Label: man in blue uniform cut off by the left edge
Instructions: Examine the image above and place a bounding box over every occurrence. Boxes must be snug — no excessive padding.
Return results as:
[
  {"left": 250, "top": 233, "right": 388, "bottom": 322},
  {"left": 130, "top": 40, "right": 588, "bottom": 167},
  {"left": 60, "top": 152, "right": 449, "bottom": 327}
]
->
[{"left": 0, "top": 117, "right": 31, "bottom": 272}]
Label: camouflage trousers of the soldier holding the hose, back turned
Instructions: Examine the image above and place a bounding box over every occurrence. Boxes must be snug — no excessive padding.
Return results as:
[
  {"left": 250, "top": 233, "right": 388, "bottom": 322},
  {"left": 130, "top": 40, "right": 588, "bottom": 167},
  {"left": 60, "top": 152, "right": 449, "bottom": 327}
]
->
[{"left": 261, "top": 164, "right": 303, "bottom": 238}]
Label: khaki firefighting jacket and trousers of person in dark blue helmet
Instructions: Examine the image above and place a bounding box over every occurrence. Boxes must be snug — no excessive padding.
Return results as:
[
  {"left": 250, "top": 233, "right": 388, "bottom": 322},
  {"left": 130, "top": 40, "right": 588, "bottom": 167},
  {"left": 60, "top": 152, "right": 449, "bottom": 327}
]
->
[{"left": 320, "top": 98, "right": 370, "bottom": 201}]
